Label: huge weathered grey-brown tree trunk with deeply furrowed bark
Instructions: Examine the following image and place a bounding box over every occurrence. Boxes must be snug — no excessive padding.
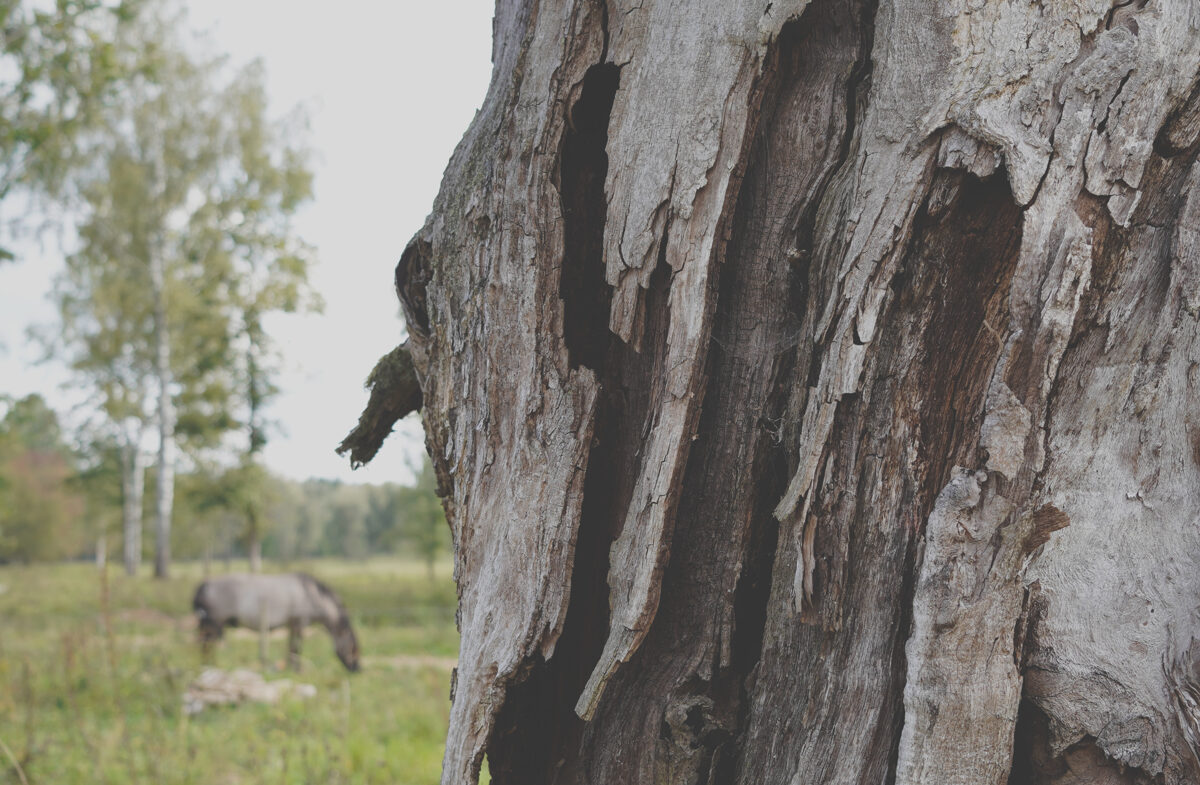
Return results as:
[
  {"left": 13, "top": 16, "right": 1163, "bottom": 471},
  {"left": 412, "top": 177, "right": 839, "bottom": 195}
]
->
[{"left": 362, "top": 0, "right": 1200, "bottom": 785}]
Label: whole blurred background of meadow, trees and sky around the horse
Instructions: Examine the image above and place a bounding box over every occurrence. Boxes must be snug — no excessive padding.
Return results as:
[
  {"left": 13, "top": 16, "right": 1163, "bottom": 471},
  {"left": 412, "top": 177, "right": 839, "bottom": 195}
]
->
[{"left": 0, "top": 0, "right": 492, "bottom": 783}]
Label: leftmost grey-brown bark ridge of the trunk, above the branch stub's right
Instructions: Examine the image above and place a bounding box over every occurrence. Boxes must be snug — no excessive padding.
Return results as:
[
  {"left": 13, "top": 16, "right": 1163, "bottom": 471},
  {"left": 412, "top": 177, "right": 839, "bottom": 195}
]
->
[{"left": 408, "top": 0, "right": 619, "bottom": 785}]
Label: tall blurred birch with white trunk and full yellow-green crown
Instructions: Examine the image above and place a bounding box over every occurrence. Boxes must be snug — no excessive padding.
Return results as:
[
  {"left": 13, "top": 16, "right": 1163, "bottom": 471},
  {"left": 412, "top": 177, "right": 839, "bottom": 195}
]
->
[{"left": 48, "top": 3, "right": 319, "bottom": 576}]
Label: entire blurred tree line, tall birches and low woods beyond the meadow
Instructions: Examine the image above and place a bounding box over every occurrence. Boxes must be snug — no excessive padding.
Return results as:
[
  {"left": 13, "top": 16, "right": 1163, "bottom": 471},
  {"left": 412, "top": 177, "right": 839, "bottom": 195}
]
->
[{"left": 0, "top": 0, "right": 436, "bottom": 576}]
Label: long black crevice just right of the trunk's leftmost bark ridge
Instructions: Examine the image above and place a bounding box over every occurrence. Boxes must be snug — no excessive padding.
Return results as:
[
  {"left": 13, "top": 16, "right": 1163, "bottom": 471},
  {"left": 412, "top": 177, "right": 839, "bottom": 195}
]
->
[{"left": 488, "top": 57, "right": 624, "bottom": 784}]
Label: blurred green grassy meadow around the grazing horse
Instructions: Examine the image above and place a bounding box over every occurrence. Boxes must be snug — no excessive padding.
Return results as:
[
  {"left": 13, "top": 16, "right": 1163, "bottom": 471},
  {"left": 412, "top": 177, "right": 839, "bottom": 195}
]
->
[{"left": 0, "top": 559, "right": 458, "bottom": 785}]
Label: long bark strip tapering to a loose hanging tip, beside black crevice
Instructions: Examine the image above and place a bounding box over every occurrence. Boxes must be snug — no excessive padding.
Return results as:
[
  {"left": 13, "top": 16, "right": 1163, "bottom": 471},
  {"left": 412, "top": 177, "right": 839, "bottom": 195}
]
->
[{"left": 576, "top": 2, "right": 825, "bottom": 719}]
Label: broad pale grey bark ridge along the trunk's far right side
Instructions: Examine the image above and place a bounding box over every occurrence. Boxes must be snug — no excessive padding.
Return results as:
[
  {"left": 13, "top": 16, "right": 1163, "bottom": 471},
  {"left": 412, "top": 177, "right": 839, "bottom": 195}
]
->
[{"left": 1014, "top": 132, "right": 1200, "bottom": 785}]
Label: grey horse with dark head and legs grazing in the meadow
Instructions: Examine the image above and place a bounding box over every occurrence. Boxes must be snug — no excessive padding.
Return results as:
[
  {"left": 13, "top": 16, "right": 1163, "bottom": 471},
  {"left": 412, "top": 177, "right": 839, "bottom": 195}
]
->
[{"left": 192, "top": 573, "right": 359, "bottom": 671}]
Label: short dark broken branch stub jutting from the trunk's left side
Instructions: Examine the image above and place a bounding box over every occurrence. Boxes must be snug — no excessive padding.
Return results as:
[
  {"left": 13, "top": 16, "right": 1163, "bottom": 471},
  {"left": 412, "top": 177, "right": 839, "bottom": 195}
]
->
[{"left": 337, "top": 341, "right": 421, "bottom": 469}]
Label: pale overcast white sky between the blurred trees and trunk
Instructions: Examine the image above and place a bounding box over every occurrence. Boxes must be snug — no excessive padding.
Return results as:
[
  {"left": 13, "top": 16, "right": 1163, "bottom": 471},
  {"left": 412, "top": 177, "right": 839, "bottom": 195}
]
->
[{"left": 0, "top": 0, "right": 493, "bottom": 483}]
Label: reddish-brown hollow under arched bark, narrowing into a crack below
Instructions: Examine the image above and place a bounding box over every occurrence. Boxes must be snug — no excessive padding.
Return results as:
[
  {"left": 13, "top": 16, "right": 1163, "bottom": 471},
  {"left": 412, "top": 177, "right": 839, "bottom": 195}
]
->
[{"left": 873, "top": 170, "right": 1022, "bottom": 783}]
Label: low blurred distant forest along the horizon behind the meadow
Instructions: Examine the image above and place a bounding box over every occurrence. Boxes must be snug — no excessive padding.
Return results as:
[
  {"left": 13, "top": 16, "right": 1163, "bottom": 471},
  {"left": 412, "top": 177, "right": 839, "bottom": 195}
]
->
[{"left": 0, "top": 395, "right": 450, "bottom": 563}]
